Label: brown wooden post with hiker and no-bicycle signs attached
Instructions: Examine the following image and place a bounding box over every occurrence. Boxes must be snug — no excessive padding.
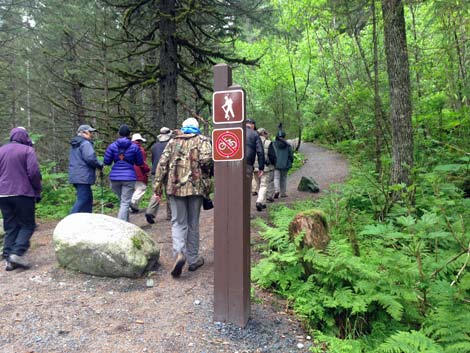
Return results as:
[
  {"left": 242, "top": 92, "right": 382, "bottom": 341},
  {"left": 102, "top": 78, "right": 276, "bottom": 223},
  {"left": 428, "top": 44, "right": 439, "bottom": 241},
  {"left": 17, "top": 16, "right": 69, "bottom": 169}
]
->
[{"left": 212, "top": 64, "right": 251, "bottom": 327}]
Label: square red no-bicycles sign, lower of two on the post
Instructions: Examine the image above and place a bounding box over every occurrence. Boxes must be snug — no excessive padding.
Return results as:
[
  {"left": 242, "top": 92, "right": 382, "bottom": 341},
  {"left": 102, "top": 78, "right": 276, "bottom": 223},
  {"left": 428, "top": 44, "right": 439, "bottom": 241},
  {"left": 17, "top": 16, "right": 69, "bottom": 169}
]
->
[{"left": 212, "top": 128, "right": 243, "bottom": 161}]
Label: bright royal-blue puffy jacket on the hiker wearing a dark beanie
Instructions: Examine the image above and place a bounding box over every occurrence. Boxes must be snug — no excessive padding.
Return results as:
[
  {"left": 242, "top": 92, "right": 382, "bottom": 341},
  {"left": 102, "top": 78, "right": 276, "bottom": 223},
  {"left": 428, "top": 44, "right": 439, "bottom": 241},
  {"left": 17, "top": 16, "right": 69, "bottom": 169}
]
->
[{"left": 104, "top": 137, "right": 144, "bottom": 181}]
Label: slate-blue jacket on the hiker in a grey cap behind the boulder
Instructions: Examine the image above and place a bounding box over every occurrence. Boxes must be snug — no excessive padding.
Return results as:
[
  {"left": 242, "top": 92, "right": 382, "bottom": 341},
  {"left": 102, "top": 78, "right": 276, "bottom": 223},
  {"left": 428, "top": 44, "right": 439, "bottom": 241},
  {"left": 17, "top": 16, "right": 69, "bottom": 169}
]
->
[{"left": 69, "top": 136, "right": 103, "bottom": 185}]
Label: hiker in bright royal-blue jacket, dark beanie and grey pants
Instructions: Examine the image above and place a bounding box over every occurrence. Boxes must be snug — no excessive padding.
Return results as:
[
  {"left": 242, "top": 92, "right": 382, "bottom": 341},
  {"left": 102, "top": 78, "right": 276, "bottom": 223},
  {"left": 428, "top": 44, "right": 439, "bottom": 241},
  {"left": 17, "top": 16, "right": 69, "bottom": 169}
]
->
[{"left": 104, "top": 124, "right": 144, "bottom": 222}]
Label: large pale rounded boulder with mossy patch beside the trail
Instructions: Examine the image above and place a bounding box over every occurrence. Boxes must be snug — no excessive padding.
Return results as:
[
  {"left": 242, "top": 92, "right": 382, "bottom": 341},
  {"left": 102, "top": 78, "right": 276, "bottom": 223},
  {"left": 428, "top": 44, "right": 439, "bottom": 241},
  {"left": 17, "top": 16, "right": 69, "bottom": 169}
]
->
[{"left": 53, "top": 213, "right": 160, "bottom": 278}]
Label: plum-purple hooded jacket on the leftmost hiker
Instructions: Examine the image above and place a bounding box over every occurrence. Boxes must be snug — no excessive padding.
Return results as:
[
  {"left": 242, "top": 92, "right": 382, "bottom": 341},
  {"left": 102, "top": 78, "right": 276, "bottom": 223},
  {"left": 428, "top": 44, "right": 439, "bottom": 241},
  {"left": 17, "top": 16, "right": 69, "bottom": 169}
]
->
[{"left": 0, "top": 128, "right": 41, "bottom": 197}]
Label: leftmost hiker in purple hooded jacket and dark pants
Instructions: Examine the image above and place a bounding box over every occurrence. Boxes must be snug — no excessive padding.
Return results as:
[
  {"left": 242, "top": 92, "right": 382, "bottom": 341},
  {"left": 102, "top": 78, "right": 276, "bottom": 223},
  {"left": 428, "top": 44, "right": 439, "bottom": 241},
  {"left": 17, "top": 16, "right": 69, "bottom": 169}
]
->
[{"left": 0, "top": 128, "right": 42, "bottom": 271}]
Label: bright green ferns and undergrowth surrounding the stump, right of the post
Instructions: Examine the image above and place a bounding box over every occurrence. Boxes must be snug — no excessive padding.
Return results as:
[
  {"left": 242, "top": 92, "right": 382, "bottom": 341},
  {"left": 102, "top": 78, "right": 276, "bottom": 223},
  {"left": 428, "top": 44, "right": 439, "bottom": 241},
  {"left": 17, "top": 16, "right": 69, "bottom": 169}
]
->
[{"left": 252, "top": 153, "right": 470, "bottom": 353}]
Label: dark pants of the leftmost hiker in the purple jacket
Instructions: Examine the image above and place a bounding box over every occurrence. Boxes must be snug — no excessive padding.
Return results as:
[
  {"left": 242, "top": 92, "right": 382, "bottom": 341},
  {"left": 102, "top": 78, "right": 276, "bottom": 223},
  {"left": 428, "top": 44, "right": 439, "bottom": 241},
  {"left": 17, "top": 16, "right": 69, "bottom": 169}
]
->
[{"left": 0, "top": 196, "right": 36, "bottom": 258}]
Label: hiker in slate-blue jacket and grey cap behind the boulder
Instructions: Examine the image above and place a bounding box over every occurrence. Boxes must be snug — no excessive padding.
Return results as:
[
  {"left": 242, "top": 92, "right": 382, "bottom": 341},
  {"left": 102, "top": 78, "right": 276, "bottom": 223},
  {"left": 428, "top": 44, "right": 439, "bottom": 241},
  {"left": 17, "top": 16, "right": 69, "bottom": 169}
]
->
[{"left": 69, "top": 125, "right": 103, "bottom": 214}]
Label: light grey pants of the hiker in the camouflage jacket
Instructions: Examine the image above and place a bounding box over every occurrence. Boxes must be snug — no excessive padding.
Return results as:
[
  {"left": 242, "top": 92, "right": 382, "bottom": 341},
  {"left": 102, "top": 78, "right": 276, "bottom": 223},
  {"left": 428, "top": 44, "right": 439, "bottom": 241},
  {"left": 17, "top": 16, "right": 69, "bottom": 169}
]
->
[{"left": 169, "top": 195, "right": 203, "bottom": 265}]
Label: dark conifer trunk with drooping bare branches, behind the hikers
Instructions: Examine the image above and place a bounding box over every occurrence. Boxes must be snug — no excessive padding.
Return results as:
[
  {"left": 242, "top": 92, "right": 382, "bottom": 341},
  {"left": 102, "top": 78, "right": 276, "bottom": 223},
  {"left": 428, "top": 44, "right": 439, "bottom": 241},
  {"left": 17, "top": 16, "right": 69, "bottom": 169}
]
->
[{"left": 157, "top": 0, "right": 178, "bottom": 128}]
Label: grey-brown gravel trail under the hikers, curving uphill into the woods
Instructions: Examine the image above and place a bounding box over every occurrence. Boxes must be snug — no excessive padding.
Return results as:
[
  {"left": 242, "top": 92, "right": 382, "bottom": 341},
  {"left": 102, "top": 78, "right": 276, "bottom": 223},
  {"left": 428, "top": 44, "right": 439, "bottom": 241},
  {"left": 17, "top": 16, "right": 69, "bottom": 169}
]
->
[{"left": 0, "top": 144, "right": 348, "bottom": 353}]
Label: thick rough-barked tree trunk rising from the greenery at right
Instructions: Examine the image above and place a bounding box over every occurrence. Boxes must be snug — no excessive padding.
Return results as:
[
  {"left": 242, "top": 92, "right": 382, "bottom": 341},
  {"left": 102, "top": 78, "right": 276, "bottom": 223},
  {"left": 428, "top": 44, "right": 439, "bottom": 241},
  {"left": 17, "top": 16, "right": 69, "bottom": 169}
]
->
[{"left": 382, "top": 0, "right": 413, "bottom": 185}]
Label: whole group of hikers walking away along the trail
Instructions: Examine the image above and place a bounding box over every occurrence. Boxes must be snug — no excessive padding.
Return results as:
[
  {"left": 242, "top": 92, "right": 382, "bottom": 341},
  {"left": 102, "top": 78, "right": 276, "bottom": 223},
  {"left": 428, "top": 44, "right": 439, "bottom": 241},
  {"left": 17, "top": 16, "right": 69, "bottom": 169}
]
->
[{"left": 0, "top": 117, "right": 293, "bottom": 277}]
